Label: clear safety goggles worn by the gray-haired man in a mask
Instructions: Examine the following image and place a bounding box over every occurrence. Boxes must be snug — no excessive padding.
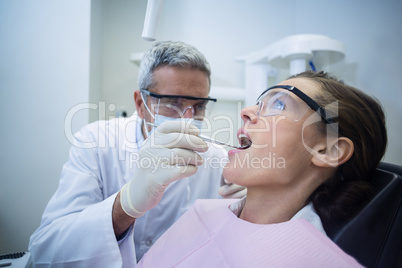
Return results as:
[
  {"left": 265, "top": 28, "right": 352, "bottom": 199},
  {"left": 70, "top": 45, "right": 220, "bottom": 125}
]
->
[{"left": 141, "top": 89, "right": 216, "bottom": 120}]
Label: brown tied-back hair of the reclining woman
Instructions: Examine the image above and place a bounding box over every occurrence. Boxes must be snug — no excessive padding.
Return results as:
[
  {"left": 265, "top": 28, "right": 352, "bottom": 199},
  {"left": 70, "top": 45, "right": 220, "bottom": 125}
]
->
[{"left": 290, "top": 71, "right": 387, "bottom": 232}]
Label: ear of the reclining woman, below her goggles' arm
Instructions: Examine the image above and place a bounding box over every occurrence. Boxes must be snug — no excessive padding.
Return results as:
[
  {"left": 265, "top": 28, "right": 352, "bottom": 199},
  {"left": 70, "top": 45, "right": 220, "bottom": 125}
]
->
[{"left": 311, "top": 137, "right": 354, "bottom": 167}]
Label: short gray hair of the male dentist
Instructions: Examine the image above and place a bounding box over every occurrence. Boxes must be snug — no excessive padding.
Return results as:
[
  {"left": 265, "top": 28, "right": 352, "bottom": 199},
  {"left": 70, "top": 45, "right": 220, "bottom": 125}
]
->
[{"left": 138, "top": 41, "right": 211, "bottom": 89}]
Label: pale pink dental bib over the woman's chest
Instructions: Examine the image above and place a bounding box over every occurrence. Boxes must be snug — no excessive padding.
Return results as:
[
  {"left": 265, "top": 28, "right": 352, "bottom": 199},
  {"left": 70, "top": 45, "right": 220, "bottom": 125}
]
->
[{"left": 138, "top": 199, "right": 362, "bottom": 267}]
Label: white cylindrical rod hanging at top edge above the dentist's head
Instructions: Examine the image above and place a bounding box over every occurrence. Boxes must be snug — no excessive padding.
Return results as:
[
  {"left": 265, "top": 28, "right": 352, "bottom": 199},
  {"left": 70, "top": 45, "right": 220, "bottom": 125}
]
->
[{"left": 142, "top": 0, "right": 163, "bottom": 42}]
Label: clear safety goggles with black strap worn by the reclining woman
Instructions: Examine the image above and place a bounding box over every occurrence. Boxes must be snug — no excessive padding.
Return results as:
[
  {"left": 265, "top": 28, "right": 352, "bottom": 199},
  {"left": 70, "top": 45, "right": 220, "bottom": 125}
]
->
[{"left": 256, "top": 85, "right": 335, "bottom": 124}]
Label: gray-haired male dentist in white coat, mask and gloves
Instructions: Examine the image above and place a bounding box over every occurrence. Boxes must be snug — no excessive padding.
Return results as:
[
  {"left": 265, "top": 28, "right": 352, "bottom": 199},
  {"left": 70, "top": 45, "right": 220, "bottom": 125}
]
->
[{"left": 29, "top": 41, "right": 245, "bottom": 267}]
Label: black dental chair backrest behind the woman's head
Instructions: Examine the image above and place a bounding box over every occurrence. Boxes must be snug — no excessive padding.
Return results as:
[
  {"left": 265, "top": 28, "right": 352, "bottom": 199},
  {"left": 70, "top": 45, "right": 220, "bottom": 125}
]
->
[{"left": 327, "top": 162, "right": 402, "bottom": 267}]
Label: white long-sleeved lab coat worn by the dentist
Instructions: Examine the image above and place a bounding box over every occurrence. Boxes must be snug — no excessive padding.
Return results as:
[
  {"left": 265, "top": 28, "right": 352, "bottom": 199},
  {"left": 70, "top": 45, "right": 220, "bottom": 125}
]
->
[{"left": 29, "top": 114, "right": 226, "bottom": 268}]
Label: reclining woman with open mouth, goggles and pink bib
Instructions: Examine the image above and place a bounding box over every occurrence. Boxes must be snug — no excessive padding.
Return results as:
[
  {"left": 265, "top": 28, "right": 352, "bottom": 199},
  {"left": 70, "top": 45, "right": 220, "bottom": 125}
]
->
[{"left": 139, "top": 72, "right": 387, "bottom": 267}]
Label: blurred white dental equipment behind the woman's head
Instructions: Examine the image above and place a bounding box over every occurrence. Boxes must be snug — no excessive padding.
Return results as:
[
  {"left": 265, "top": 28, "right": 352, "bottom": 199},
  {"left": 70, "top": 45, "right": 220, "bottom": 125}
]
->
[{"left": 237, "top": 34, "right": 345, "bottom": 107}]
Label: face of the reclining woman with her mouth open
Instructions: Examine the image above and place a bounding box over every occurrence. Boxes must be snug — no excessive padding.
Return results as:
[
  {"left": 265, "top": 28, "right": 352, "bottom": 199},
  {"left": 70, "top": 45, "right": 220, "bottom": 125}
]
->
[{"left": 223, "top": 78, "right": 322, "bottom": 189}]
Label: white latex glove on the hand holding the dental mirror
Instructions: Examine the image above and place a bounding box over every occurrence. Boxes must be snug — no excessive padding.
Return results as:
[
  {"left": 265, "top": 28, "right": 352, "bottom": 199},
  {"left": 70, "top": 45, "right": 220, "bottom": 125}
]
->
[{"left": 120, "top": 121, "right": 208, "bottom": 218}]
